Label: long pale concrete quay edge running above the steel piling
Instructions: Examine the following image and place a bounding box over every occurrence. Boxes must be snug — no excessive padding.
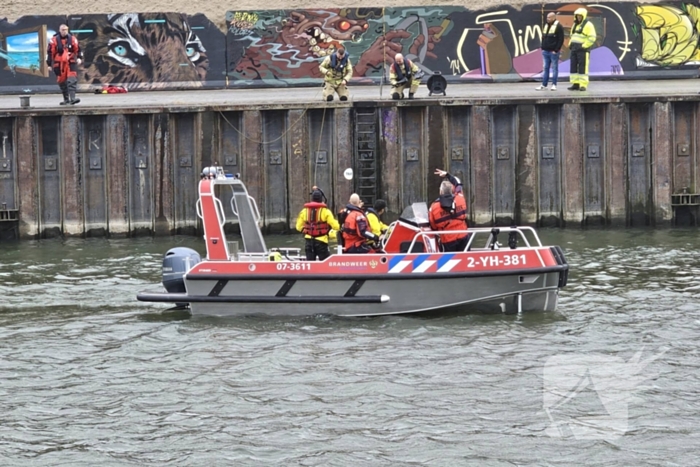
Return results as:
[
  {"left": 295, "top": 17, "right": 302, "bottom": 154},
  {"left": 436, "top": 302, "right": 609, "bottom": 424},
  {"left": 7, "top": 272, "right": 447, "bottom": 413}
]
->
[{"left": 0, "top": 79, "right": 700, "bottom": 117}]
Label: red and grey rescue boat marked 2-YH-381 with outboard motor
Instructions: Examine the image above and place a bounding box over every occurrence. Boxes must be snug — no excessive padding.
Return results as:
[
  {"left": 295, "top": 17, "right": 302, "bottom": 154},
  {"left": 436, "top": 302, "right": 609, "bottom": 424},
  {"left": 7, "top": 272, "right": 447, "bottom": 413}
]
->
[{"left": 137, "top": 167, "right": 569, "bottom": 316}]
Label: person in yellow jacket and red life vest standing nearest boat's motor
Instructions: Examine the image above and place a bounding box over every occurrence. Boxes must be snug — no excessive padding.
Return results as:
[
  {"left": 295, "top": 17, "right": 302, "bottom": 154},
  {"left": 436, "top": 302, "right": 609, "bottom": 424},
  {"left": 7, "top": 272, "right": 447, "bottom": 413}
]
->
[{"left": 297, "top": 187, "right": 340, "bottom": 261}]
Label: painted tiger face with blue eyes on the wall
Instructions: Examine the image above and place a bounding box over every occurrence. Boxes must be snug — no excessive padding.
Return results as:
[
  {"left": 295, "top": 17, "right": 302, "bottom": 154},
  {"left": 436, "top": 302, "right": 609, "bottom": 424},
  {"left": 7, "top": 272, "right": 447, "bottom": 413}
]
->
[{"left": 74, "top": 13, "right": 209, "bottom": 89}]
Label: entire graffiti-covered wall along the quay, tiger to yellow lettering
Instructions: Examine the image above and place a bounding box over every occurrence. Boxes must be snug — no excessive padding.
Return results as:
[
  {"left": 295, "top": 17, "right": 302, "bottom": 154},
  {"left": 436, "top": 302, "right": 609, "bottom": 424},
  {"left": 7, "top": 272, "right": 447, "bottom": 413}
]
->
[{"left": 0, "top": 3, "right": 700, "bottom": 92}]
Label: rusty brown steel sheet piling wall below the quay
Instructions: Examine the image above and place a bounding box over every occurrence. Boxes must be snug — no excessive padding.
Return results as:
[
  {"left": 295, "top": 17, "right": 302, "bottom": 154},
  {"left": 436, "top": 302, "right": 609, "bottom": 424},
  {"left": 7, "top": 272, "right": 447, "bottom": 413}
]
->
[{"left": 0, "top": 98, "right": 700, "bottom": 238}]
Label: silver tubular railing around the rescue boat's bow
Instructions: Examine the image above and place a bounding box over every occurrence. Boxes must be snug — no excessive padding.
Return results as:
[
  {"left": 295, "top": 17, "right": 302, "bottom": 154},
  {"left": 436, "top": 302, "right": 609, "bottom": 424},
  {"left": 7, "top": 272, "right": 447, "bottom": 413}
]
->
[{"left": 396, "top": 226, "right": 542, "bottom": 253}]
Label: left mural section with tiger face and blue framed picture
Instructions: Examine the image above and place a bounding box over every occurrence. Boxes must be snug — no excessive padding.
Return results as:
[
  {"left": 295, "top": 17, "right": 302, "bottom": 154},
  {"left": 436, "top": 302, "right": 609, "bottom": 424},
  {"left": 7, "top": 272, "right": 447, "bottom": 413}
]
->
[{"left": 0, "top": 13, "right": 225, "bottom": 90}]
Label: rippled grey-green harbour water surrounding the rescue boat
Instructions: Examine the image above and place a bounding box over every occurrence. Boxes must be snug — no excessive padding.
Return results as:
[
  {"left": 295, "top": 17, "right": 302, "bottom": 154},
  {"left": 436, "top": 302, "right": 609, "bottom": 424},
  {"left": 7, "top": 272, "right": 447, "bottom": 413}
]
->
[{"left": 0, "top": 230, "right": 700, "bottom": 466}]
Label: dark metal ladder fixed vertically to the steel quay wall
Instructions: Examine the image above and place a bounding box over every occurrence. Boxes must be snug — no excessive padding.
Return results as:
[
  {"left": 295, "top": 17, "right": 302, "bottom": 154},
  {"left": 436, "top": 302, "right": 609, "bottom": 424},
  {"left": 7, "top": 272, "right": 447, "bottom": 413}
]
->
[{"left": 355, "top": 107, "right": 379, "bottom": 206}]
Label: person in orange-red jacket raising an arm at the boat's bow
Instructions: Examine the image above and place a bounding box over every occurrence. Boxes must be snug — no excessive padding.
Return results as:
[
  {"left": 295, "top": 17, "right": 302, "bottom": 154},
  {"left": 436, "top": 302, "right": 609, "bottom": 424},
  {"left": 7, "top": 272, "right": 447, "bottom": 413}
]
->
[{"left": 428, "top": 169, "right": 469, "bottom": 251}]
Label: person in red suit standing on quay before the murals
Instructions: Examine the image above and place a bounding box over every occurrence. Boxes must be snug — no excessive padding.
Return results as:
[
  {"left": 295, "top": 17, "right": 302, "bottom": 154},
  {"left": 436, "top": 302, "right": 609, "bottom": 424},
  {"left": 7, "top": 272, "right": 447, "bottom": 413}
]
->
[{"left": 46, "top": 24, "right": 83, "bottom": 105}]
